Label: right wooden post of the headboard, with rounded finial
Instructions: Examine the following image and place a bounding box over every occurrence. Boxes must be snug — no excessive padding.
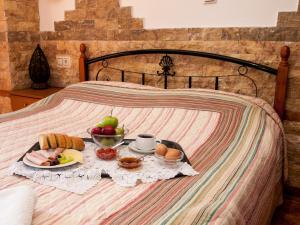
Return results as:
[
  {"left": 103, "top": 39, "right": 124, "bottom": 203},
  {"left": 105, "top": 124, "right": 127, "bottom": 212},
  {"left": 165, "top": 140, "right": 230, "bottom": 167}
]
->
[{"left": 274, "top": 46, "right": 290, "bottom": 120}]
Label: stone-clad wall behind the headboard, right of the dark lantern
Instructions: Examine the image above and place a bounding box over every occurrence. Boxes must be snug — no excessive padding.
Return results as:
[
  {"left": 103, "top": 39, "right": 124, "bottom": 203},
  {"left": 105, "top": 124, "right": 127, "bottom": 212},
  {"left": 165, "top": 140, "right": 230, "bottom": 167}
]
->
[{"left": 41, "top": 0, "right": 300, "bottom": 118}]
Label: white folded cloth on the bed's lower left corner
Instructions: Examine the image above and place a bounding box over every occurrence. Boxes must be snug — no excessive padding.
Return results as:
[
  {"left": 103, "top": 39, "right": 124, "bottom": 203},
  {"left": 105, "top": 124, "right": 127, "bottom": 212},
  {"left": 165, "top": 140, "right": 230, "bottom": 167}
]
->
[{"left": 0, "top": 186, "right": 36, "bottom": 225}]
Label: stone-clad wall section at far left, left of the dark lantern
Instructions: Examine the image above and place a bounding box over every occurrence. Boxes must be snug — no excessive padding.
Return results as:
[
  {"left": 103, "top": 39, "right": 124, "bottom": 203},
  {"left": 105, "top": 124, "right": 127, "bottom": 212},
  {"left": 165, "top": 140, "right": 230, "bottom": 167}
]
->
[{"left": 0, "top": 0, "right": 40, "bottom": 113}]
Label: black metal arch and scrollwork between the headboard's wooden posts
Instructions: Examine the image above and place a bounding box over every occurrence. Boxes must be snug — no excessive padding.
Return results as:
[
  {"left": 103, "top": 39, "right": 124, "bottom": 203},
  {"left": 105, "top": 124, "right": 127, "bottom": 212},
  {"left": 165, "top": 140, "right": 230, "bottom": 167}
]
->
[{"left": 84, "top": 49, "right": 278, "bottom": 96}]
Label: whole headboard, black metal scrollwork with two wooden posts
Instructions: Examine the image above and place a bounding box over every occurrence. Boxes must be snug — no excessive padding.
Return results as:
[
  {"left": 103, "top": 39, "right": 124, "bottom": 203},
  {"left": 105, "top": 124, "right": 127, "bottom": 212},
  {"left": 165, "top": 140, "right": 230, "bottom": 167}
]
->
[{"left": 79, "top": 44, "right": 290, "bottom": 119}]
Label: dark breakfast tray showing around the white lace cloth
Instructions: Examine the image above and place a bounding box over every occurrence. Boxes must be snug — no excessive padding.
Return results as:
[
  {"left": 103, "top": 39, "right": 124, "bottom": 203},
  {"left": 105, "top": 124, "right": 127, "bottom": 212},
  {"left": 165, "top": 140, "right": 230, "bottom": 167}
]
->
[{"left": 18, "top": 138, "right": 191, "bottom": 178}]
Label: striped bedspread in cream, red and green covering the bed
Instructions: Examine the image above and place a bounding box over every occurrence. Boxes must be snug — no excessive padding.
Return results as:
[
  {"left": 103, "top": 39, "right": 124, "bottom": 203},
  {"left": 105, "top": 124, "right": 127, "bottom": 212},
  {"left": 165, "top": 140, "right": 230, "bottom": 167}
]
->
[{"left": 0, "top": 82, "right": 285, "bottom": 225}]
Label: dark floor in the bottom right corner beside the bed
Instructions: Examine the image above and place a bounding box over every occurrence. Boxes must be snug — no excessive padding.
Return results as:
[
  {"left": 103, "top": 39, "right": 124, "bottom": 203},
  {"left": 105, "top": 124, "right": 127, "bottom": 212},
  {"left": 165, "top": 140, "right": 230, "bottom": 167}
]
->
[{"left": 271, "top": 194, "right": 300, "bottom": 225}]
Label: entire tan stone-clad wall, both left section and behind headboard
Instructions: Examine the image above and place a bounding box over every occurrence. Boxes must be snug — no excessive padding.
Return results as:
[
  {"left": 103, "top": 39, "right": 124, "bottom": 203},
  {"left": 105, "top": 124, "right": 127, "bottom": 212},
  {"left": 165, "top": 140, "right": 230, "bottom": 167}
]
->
[{"left": 0, "top": 0, "right": 300, "bottom": 187}]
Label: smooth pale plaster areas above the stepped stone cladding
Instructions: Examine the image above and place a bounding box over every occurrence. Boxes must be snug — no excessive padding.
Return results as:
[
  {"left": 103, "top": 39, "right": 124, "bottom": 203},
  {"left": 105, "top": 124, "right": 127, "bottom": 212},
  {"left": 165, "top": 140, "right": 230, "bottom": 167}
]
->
[{"left": 39, "top": 0, "right": 298, "bottom": 31}]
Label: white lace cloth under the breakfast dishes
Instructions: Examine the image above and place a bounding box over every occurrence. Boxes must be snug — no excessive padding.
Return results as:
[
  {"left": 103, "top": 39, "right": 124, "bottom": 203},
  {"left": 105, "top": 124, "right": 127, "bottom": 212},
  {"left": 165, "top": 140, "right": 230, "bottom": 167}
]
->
[{"left": 9, "top": 142, "right": 198, "bottom": 194}]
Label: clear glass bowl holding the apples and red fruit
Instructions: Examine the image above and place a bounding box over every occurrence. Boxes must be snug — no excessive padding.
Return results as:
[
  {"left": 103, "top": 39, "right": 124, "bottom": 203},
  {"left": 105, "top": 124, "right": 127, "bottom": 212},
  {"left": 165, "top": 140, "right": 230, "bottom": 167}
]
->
[{"left": 87, "top": 128, "right": 128, "bottom": 148}]
